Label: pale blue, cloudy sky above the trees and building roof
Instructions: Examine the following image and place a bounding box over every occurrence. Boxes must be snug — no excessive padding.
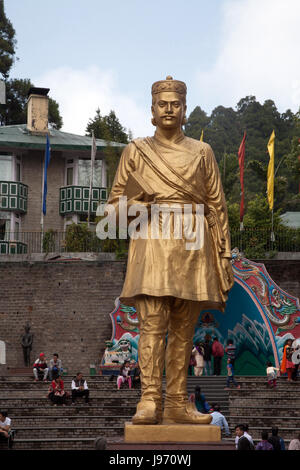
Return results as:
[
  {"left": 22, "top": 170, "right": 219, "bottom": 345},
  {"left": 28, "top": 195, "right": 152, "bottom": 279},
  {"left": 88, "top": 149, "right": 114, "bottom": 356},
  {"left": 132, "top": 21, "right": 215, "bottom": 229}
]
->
[{"left": 4, "top": 0, "right": 300, "bottom": 137}]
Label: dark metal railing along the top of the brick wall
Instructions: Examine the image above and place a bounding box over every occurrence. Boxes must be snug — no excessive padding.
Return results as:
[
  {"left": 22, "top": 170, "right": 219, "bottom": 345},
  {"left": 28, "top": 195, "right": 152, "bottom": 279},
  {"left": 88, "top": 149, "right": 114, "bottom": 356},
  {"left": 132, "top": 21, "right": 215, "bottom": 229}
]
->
[{"left": 0, "top": 228, "right": 300, "bottom": 259}]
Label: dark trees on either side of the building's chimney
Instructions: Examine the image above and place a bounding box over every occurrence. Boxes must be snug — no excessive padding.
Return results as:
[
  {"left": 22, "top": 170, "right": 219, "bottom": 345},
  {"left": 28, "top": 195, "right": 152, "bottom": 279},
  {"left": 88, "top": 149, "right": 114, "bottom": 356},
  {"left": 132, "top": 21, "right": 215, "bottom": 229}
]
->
[{"left": 0, "top": 78, "right": 63, "bottom": 129}]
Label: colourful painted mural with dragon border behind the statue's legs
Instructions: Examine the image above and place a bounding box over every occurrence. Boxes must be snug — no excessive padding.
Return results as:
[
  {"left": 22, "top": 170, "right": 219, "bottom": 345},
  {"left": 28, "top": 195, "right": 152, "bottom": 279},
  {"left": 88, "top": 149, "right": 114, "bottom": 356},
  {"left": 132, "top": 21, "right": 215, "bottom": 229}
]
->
[{"left": 100, "top": 250, "right": 300, "bottom": 375}]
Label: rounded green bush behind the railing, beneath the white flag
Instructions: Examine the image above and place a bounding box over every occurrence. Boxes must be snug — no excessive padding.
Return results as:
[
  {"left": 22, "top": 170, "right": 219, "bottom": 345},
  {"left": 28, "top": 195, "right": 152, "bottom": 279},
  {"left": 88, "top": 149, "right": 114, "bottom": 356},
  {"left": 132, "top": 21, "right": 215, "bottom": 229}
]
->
[{"left": 65, "top": 223, "right": 101, "bottom": 252}]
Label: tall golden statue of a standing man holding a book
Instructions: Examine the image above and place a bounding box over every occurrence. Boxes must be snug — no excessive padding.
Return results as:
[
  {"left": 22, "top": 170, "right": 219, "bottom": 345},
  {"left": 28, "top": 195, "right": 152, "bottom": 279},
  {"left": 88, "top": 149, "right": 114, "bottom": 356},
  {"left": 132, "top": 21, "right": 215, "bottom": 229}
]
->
[{"left": 108, "top": 77, "right": 233, "bottom": 424}]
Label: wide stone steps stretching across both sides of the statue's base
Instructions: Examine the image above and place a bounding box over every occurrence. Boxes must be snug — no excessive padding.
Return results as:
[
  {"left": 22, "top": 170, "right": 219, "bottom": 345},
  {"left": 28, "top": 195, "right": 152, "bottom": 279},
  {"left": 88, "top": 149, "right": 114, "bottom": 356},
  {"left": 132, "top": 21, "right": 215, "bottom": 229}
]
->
[{"left": 0, "top": 374, "right": 300, "bottom": 450}]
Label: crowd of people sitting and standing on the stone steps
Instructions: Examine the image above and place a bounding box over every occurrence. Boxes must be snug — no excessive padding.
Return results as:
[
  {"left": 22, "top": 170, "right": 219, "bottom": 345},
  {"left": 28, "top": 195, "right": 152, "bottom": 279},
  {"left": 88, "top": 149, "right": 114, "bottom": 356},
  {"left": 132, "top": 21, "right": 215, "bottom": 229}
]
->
[{"left": 0, "top": 336, "right": 300, "bottom": 450}]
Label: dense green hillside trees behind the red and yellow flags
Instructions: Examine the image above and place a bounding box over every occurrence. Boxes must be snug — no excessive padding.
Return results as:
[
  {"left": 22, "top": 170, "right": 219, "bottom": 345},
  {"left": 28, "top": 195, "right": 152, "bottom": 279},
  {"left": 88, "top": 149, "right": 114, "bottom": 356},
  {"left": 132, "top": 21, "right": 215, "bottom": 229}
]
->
[{"left": 185, "top": 96, "right": 300, "bottom": 217}]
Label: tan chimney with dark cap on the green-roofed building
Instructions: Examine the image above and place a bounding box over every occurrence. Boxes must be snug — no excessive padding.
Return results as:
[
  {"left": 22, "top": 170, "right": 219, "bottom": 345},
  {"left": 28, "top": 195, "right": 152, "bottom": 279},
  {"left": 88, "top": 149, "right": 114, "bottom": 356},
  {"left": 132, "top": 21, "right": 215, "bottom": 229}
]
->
[{"left": 27, "top": 87, "right": 50, "bottom": 135}]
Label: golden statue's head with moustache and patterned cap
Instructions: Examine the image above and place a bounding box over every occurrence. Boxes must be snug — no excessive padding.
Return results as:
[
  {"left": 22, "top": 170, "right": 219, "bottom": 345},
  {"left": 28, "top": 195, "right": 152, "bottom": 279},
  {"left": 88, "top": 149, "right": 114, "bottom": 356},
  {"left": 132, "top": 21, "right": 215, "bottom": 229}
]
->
[{"left": 151, "top": 76, "right": 186, "bottom": 129}]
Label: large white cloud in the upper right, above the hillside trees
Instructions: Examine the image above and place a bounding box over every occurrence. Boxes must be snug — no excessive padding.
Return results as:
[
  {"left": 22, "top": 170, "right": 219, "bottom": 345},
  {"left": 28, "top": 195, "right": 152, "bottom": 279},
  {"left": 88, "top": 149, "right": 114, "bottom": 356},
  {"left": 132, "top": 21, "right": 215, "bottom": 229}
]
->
[{"left": 197, "top": 0, "right": 300, "bottom": 112}]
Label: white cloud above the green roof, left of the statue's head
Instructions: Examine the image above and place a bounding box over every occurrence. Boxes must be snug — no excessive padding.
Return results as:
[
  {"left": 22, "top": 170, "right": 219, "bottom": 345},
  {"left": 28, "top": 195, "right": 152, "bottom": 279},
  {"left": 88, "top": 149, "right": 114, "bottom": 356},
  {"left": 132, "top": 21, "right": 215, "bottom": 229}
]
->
[{"left": 32, "top": 66, "right": 153, "bottom": 137}]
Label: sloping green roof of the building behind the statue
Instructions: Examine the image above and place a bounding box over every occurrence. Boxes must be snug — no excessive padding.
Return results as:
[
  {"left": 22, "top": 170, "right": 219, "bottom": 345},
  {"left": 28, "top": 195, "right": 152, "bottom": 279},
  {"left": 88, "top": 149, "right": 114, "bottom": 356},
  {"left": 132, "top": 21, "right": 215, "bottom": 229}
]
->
[{"left": 0, "top": 124, "right": 125, "bottom": 151}]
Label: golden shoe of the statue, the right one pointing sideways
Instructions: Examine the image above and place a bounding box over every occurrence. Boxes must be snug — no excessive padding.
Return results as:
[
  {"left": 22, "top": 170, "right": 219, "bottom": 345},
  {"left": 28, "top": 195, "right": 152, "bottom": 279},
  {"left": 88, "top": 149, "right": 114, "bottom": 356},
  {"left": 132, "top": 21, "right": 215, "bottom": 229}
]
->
[{"left": 163, "top": 403, "right": 212, "bottom": 424}]
